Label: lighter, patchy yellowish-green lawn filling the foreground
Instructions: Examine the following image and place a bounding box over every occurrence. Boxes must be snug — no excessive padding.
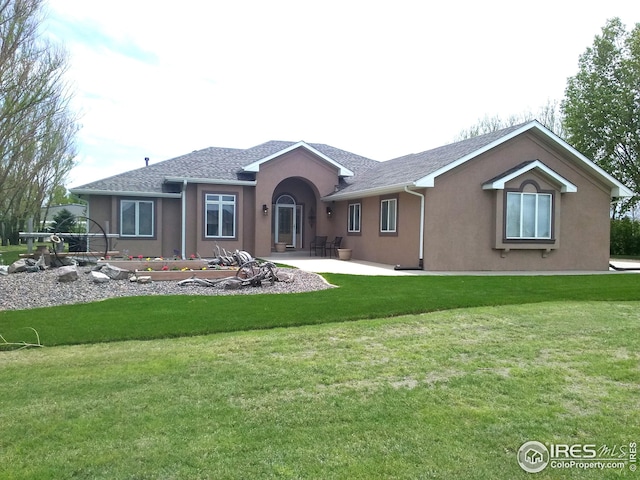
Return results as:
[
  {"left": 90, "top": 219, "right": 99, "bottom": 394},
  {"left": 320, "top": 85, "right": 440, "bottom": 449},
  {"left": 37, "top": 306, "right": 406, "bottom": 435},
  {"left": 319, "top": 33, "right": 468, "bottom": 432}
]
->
[{"left": 0, "top": 299, "right": 640, "bottom": 479}]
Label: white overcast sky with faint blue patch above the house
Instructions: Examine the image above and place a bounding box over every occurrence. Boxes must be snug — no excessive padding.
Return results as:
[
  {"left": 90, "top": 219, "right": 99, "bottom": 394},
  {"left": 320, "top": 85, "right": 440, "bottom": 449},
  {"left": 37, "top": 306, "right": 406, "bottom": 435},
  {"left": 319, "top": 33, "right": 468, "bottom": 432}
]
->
[{"left": 44, "top": 0, "right": 640, "bottom": 187}]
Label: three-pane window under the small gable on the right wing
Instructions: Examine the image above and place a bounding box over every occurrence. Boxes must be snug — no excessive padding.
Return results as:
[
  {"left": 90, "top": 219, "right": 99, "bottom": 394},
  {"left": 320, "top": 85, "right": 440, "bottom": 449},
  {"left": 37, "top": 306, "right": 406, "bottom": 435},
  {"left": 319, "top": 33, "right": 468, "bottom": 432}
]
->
[{"left": 506, "top": 192, "right": 553, "bottom": 240}]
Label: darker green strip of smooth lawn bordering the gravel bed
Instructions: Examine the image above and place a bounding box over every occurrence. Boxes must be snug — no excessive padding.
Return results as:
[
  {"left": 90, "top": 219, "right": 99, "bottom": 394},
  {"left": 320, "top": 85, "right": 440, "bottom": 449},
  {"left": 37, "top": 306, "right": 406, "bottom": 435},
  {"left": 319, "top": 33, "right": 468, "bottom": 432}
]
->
[{"left": 0, "top": 274, "right": 640, "bottom": 346}]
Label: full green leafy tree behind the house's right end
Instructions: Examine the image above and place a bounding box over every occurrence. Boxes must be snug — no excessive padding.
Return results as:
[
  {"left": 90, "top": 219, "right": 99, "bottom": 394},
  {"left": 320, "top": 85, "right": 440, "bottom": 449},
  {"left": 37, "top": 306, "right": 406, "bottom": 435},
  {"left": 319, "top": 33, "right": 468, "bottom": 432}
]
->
[{"left": 561, "top": 18, "right": 640, "bottom": 216}]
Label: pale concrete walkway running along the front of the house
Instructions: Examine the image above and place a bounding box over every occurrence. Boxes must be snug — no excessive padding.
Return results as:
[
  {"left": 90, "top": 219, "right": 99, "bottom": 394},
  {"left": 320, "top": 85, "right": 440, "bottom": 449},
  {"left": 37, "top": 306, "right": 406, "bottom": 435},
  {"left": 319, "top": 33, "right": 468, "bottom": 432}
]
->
[{"left": 263, "top": 252, "right": 640, "bottom": 276}]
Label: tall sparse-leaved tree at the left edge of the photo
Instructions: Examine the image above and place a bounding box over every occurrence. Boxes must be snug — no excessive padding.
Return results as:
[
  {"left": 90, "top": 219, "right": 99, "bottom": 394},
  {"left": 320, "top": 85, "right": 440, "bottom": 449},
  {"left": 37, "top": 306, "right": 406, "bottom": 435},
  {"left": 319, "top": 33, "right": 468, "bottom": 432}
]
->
[{"left": 0, "top": 0, "right": 77, "bottom": 243}]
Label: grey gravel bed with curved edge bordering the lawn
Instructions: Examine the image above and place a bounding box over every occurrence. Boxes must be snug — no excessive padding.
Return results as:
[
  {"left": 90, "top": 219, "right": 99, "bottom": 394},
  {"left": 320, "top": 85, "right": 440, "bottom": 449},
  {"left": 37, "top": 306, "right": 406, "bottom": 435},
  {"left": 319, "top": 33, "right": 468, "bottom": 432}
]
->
[{"left": 0, "top": 267, "right": 332, "bottom": 311}]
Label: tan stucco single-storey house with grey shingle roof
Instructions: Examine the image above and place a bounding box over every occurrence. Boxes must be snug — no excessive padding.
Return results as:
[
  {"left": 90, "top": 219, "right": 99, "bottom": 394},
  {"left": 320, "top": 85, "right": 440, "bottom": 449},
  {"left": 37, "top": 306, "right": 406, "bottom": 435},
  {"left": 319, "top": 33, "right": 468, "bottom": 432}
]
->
[{"left": 71, "top": 121, "right": 633, "bottom": 271}]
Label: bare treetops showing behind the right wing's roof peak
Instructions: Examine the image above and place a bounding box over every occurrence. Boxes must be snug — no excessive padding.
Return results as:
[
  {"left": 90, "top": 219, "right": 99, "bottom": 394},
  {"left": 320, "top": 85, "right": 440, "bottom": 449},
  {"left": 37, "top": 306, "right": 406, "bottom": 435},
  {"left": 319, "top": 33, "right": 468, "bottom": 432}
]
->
[{"left": 455, "top": 100, "right": 564, "bottom": 141}]
